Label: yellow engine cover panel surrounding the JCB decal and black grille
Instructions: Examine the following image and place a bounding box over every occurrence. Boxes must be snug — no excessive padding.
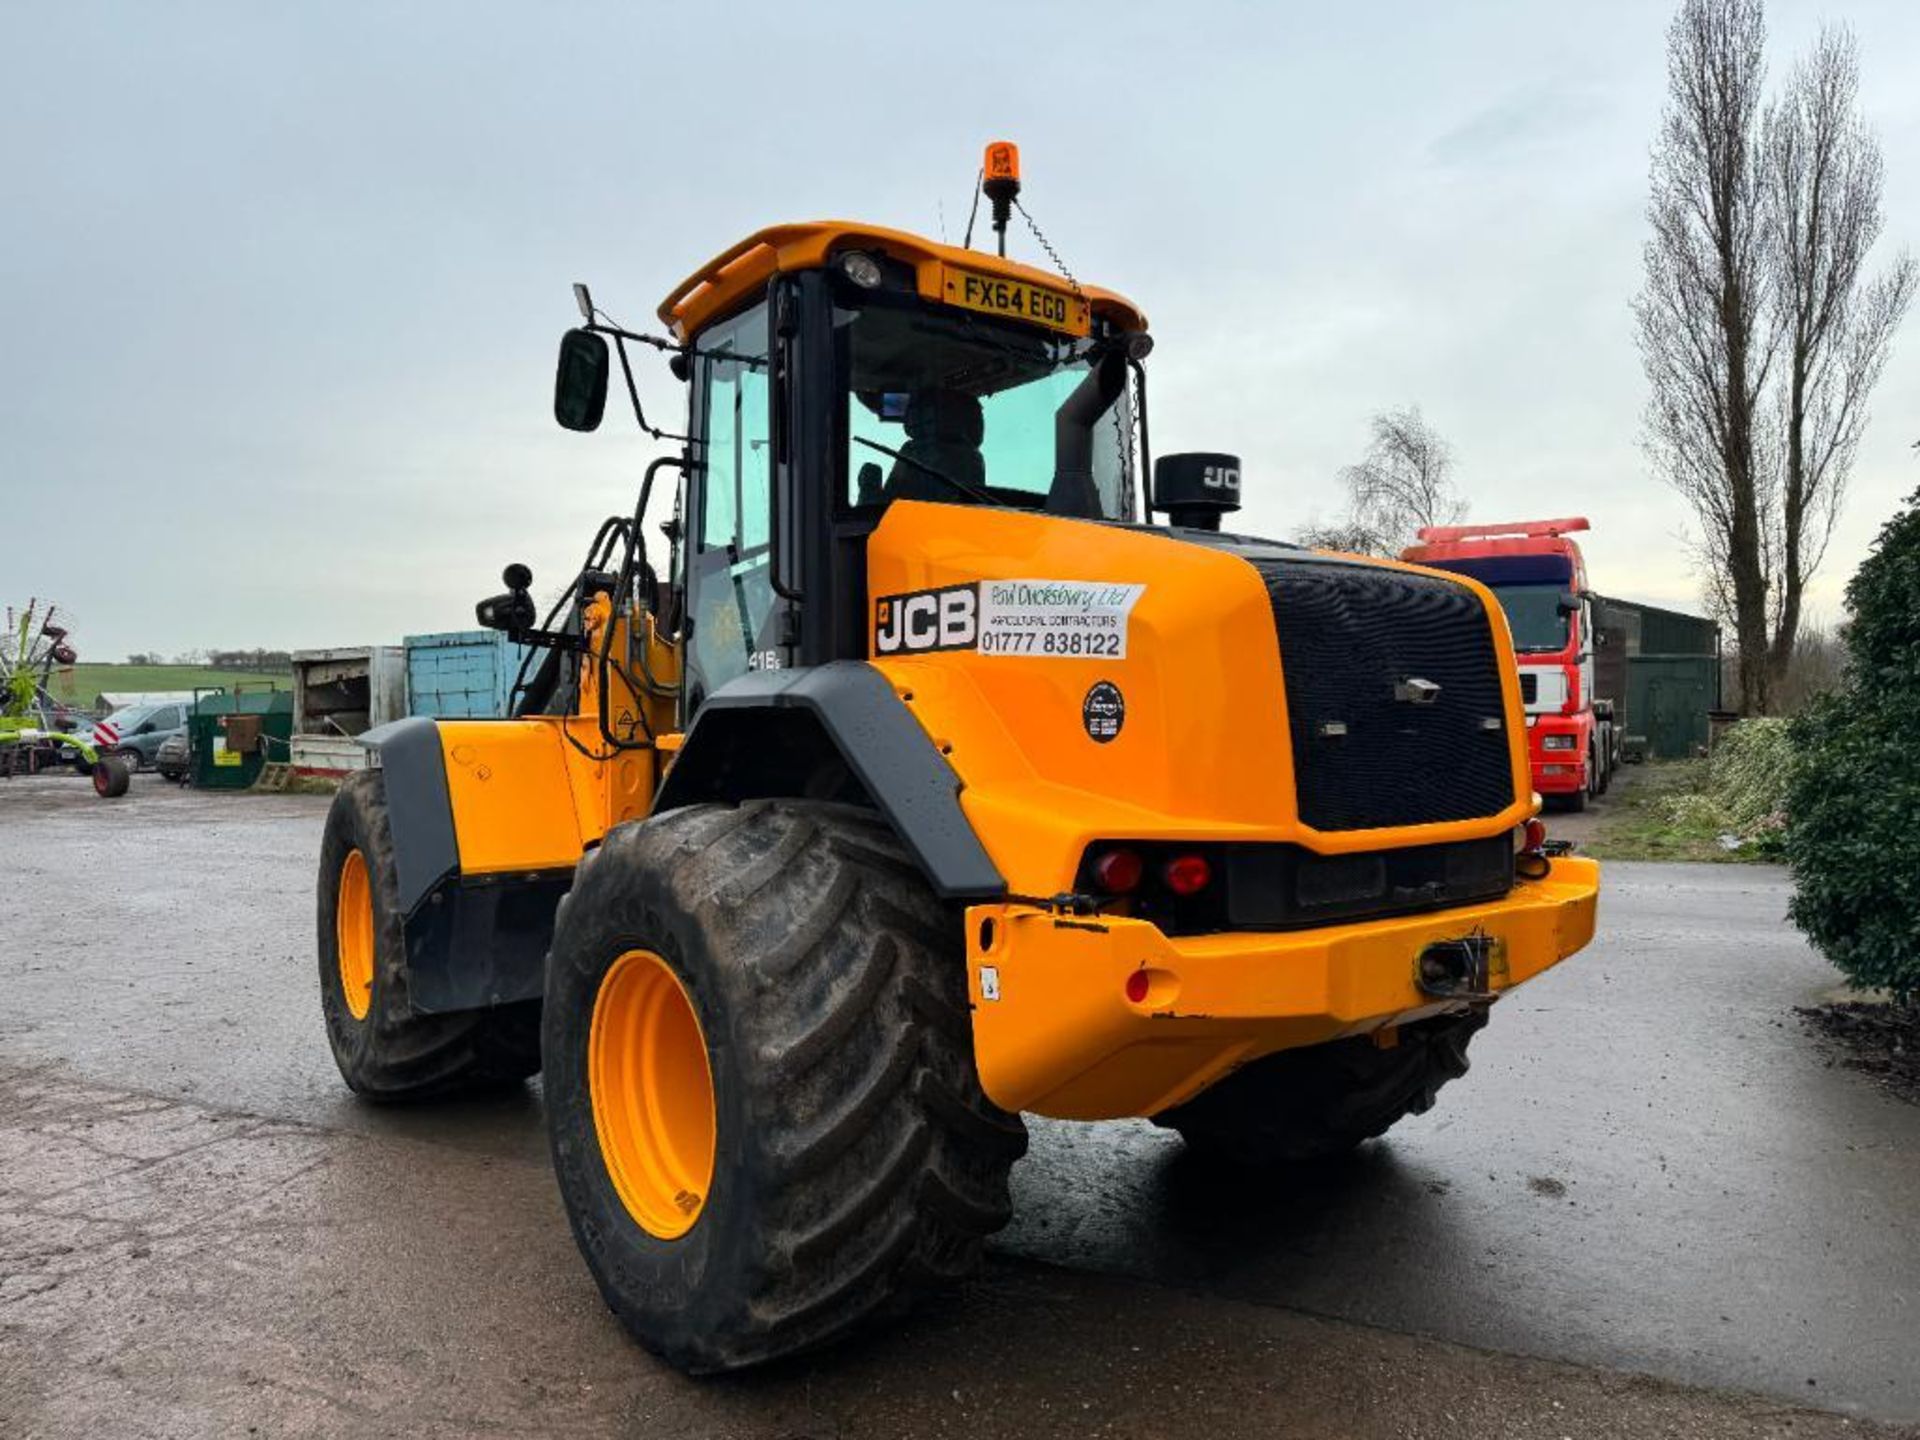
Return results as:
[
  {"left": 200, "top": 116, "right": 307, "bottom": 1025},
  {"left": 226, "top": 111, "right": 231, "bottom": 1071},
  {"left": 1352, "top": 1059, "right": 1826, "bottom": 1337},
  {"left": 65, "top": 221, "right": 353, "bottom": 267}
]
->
[{"left": 868, "top": 501, "right": 1536, "bottom": 895}]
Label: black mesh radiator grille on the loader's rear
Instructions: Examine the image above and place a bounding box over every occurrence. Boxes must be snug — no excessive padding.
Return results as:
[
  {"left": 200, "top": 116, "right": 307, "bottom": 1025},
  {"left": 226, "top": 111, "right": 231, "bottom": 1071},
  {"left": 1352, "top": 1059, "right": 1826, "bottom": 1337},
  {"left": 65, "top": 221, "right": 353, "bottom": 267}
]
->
[{"left": 1250, "top": 555, "right": 1513, "bottom": 829}]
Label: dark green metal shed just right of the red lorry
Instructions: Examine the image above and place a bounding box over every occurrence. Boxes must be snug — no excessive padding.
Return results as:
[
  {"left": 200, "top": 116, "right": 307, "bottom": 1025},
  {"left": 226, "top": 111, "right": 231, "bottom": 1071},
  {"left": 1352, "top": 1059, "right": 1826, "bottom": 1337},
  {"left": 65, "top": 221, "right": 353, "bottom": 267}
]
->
[{"left": 1594, "top": 595, "right": 1720, "bottom": 760}]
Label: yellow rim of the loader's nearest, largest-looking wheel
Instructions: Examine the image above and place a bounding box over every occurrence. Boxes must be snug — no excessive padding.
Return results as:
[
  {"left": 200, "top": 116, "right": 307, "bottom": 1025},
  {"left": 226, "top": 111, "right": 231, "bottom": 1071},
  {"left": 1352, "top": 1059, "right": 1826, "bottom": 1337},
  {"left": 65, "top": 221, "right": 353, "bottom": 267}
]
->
[{"left": 588, "top": 950, "right": 716, "bottom": 1240}]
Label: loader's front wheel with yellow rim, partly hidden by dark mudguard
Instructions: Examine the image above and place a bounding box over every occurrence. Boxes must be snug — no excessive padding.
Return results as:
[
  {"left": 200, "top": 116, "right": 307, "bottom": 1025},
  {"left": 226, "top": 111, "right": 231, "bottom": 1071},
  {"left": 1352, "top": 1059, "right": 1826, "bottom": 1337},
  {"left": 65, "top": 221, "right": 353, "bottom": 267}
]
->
[{"left": 319, "top": 770, "right": 540, "bottom": 1100}]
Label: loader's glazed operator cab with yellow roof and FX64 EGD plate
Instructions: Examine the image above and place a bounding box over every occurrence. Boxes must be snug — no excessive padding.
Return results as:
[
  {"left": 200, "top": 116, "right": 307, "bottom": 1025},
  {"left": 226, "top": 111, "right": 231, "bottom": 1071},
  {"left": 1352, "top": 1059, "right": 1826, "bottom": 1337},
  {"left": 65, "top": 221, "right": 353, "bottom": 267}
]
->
[{"left": 645, "top": 223, "right": 1150, "bottom": 720}]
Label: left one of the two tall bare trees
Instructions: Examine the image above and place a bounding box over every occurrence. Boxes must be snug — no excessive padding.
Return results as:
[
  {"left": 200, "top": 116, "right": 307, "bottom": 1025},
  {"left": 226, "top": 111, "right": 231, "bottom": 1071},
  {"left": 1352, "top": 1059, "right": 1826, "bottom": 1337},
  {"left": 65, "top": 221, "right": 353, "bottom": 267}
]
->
[{"left": 1634, "top": 0, "right": 1772, "bottom": 712}]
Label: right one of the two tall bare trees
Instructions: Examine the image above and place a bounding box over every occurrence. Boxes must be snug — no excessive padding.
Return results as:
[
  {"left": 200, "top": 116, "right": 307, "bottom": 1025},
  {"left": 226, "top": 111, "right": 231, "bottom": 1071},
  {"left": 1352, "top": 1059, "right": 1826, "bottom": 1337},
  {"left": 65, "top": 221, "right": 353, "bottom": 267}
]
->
[{"left": 1761, "top": 27, "right": 1914, "bottom": 699}]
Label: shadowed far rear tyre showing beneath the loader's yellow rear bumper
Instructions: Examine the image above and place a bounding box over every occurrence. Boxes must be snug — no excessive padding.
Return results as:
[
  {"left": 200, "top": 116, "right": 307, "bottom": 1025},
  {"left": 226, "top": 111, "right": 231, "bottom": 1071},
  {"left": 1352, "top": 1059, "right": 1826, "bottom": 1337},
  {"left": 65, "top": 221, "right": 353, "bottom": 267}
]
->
[{"left": 1154, "top": 1010, "right": 1486, "bottom": 1169}]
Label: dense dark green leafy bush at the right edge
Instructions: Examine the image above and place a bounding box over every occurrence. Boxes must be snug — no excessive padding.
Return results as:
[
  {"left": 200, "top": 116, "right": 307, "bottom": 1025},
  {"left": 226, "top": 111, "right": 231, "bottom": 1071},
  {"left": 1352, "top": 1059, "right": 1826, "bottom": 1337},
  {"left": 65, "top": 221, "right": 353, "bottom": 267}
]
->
[{"left": 1786, "top": 492, "right": 1920, "bottom": 1000}]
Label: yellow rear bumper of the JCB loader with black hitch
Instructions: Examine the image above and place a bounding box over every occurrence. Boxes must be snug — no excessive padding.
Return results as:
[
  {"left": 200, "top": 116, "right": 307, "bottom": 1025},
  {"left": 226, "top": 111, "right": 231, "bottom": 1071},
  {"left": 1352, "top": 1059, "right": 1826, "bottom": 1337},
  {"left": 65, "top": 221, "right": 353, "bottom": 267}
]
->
[{"left": 968, "top": 856, "right": 1599, "bottom": 1119}]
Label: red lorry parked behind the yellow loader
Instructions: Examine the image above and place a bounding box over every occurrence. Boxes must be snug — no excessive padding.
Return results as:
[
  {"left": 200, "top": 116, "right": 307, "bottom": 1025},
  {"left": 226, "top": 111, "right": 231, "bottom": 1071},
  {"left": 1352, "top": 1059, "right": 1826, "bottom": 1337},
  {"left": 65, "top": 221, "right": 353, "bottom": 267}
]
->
[{"left": 1402, "top": 516, "right": 1620, "bottom": 810}]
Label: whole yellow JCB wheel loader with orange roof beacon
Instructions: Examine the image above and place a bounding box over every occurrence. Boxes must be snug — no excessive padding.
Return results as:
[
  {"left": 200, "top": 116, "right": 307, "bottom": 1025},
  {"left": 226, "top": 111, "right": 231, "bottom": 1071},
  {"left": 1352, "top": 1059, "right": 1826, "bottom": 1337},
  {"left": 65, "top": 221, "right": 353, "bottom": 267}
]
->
[{"left": 319, "top": 146, "right": 1597, "bottom": 1371}]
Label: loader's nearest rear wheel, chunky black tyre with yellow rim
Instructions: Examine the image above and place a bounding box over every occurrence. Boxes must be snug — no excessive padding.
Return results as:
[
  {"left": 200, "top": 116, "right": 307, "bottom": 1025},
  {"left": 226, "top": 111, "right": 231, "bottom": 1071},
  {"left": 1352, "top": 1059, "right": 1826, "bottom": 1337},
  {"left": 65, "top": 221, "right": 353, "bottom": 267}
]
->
[{"left": 543, "top": 801, "right": 1027, "bottom": 1373}]
